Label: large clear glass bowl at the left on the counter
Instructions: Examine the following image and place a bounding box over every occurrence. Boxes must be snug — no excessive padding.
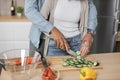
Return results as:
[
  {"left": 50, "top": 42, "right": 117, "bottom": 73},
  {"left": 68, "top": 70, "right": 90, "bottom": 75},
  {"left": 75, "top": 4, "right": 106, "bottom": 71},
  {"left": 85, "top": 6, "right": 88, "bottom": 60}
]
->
[{"left": 0, "top": 49, "right": 40, "bottom": 80}]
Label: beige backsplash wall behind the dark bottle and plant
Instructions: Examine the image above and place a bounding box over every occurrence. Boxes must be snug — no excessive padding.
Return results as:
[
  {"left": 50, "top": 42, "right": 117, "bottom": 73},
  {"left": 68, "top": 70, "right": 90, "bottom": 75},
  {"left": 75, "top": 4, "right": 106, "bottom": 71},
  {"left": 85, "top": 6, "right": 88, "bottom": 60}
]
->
[{"left": 0, "top": 0, "right": 25, "bottom": 16}]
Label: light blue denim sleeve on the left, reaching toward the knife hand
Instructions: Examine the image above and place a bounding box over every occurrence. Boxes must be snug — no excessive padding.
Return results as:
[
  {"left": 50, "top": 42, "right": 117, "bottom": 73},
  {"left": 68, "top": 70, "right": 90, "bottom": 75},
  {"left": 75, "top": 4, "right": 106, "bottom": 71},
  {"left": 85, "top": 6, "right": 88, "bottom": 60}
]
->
[{"left": 24, "top": 0, "right": 54, "bottom": 33}]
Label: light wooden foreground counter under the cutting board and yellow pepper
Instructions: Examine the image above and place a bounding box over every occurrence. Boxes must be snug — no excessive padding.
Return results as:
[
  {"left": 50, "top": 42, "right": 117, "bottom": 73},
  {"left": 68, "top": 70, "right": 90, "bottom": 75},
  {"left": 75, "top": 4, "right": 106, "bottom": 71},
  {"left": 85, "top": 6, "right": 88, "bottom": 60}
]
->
[{"left": 0, "top": 53, "right": 120, "bottom": 80}]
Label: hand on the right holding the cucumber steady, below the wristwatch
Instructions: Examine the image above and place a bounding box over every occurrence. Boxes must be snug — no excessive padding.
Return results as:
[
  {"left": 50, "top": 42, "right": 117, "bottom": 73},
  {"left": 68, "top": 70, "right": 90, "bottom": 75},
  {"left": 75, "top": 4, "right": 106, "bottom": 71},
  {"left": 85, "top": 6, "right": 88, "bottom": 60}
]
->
[{"left": 80, "top": 33, "right": 93, "bottom": 57}]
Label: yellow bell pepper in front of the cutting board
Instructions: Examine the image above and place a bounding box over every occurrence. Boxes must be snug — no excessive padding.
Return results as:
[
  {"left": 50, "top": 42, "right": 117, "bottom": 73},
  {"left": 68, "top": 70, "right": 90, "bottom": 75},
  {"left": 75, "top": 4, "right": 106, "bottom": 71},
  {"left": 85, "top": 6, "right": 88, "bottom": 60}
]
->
[{"left": 80, "top": 67, "right": 97, "bottom": 80}]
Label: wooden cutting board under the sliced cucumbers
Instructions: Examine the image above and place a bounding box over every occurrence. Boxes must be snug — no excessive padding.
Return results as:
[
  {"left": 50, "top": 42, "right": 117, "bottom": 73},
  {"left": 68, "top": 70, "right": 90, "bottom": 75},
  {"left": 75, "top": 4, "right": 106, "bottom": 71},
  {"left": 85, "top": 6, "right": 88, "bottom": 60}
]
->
[{"left": 47, "top": 56, "right": 102, "bottom": 71}]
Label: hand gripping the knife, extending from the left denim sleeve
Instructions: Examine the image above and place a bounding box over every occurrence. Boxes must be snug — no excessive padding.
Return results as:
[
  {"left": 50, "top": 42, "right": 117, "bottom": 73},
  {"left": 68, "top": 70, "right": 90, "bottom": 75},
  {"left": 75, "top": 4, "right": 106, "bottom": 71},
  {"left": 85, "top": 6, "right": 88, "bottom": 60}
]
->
[{"left": 51, "top": 27, "right": 70, "bottom": 51}]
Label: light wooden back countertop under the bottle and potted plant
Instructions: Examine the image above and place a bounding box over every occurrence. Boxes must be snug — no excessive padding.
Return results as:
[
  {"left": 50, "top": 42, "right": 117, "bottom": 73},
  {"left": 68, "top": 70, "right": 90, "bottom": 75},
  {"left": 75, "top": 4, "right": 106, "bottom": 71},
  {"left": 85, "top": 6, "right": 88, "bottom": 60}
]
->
[{"left": 0, "top": 16, "right": 29, "bottom": 22}]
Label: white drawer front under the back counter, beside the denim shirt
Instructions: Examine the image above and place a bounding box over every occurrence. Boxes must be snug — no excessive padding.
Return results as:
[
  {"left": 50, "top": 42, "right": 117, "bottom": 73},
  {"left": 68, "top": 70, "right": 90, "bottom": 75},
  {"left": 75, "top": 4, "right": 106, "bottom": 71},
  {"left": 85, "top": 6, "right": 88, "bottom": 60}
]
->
[{"left": 13, "top": 22, "right": 31, "bottom": 41}]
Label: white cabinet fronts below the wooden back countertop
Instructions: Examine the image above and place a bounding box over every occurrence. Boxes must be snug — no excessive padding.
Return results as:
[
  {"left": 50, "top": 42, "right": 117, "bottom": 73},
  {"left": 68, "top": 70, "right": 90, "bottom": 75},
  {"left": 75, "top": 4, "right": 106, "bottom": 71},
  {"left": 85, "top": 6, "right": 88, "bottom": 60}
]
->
[{"left": 0, "top": 22, "right": 31, "bottom": 52}]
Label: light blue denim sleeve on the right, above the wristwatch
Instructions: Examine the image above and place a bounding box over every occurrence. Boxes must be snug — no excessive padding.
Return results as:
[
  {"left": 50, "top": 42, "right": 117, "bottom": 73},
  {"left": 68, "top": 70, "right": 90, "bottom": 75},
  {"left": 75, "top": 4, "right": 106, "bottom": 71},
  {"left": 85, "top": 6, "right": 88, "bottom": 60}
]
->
[{"left": 88, "top": 0, "right": 97, "bottom": 31}]
